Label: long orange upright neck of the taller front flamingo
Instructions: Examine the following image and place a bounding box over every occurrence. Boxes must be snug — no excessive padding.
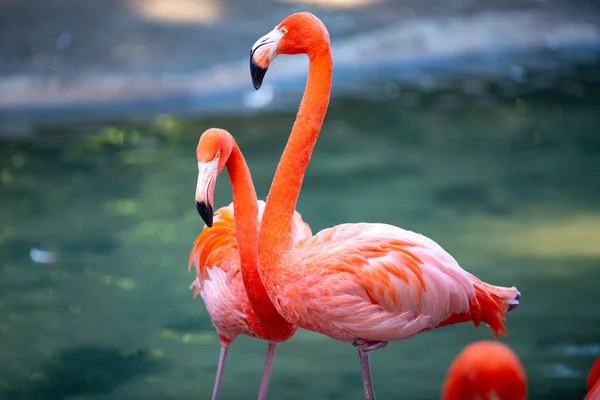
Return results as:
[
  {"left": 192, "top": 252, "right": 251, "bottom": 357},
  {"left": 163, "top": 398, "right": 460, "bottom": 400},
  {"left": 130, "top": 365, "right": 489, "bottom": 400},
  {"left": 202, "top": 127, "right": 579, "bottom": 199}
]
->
[{"left": 259, "top": 42, "right": 333, "bottom": 266}]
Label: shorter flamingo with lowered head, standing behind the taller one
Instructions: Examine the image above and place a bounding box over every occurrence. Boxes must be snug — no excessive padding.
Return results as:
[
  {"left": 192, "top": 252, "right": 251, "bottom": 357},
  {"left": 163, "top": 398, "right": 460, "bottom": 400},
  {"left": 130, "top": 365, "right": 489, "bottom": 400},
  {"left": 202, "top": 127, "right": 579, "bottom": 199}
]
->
[{"left": 188, "top": 128, "right": 312, "bottom": 400}]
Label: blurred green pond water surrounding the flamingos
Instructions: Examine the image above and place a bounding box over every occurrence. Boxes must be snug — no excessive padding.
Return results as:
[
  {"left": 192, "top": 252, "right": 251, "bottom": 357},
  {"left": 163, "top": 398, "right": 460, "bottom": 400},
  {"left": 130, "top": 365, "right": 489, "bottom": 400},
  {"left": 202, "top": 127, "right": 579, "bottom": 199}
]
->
[{"left": 0, "top": 76, "right": 600, "bottom": 400}]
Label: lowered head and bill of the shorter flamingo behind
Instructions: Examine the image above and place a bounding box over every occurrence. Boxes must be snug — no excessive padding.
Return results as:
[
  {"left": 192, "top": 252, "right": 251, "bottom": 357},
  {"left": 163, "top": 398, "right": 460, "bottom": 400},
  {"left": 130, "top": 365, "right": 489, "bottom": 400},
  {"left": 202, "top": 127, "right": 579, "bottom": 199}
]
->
[{"left": 196, "top": 128, "right": 234, "bottom": 227}]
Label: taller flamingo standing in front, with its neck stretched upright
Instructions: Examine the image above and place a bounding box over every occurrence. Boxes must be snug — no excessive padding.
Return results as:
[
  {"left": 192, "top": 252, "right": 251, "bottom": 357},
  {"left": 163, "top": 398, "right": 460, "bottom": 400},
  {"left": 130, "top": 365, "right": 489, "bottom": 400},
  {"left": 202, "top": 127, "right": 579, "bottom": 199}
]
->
[{"left": 250, "top": 12, "right": 520, "bottom": 399}]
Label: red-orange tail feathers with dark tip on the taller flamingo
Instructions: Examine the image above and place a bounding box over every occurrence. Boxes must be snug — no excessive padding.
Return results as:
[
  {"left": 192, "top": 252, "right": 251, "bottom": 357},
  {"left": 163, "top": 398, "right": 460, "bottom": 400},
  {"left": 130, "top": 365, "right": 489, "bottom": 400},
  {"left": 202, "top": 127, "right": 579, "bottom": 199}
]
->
[{"left": 438, "top": 278, "right": 521, "bottom": 339}]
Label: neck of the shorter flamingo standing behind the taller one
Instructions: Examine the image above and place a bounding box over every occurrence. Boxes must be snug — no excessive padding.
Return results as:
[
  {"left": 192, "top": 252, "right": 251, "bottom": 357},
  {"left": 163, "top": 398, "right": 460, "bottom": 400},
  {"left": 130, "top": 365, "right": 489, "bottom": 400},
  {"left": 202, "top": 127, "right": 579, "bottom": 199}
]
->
[{"left": 226, "top": 142, "right": 296, "bottom": 342}]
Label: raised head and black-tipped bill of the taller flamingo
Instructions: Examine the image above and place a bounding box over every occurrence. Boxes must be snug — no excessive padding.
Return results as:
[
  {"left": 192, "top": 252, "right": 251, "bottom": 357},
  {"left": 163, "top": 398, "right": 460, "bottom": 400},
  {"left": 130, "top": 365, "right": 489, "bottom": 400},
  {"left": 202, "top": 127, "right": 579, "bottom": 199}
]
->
[{"left": 250, "top": 12, "right": 330, "bottom": 90}]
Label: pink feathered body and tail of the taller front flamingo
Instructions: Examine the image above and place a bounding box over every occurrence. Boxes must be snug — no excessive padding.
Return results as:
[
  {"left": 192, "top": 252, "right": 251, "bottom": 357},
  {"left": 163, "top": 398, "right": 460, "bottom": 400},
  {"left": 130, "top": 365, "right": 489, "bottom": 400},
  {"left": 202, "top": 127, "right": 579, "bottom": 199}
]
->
[{"left": 263, "top": 223, "right": 519, "bottom": 342}]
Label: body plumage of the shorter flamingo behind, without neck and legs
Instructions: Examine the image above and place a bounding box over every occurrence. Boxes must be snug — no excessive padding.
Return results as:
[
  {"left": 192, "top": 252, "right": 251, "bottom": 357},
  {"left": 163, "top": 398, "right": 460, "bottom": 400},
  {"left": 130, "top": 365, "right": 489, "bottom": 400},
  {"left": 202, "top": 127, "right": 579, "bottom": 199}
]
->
[{"left": 188, "top": 200, "right": 312, "bottom": 347}]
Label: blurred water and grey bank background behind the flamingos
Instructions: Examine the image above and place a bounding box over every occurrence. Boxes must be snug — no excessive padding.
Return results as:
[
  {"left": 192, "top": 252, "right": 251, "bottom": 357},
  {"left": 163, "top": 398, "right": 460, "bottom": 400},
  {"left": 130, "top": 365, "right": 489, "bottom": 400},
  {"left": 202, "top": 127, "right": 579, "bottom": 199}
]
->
[{"left": 0, "top": 0, "right": 600, "bottom": 400}]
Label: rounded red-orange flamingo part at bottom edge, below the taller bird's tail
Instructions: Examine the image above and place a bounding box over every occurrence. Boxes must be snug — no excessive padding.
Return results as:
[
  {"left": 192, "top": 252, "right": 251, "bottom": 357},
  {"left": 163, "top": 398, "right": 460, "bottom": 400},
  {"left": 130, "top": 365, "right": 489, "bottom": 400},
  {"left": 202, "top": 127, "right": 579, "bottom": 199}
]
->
[{"left": 442, "top": 340, "right": 527, "bottom": 400}]
